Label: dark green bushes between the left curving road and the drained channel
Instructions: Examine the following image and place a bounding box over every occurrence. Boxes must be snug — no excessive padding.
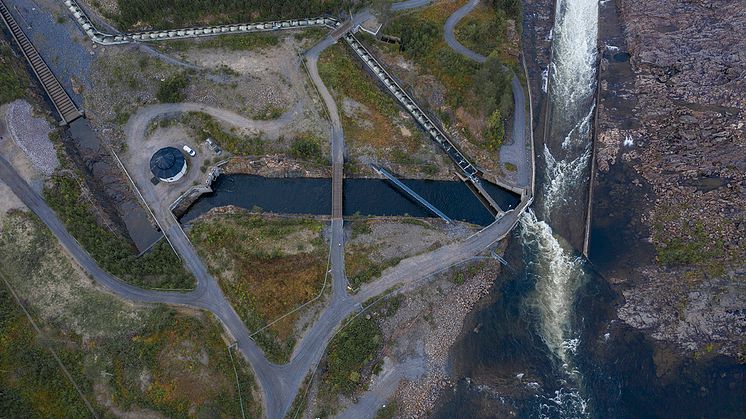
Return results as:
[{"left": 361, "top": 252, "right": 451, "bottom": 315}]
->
[{"left": 44, "top": 174, "right": 194, "bottom": 289}]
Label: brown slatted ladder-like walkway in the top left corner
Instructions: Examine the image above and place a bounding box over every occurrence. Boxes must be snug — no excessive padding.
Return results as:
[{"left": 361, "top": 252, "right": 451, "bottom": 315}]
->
[{"left": 0, "top": 0, "right": 83, "bottom": 124}]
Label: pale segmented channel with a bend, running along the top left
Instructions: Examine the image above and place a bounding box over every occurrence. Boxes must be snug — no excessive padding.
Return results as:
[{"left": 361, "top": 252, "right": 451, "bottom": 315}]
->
[{"left": 64, "top": 0, "right": 339, "bottom": 45}]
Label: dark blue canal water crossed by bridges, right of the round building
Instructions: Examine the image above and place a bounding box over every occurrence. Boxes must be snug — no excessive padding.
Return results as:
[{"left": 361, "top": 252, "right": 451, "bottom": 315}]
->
[{"left": 180, "top": 175, "right": 519, "bottom": 225}]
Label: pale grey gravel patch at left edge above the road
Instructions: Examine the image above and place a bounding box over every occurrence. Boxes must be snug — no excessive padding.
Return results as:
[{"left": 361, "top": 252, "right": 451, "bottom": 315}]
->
[{"left": 5, "top": 100, "right": 60, "bottom": 176}]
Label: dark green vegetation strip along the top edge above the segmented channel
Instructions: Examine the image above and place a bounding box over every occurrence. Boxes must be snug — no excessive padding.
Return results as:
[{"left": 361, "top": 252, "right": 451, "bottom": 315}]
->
[{"left": 112, "top": 0, "right": 354, "bottom": 30}]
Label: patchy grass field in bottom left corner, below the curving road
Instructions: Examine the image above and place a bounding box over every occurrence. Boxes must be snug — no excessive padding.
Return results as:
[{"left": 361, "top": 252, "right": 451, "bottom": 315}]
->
[{"left": 0, "top": 212, "right": 261, "bottom": 417}]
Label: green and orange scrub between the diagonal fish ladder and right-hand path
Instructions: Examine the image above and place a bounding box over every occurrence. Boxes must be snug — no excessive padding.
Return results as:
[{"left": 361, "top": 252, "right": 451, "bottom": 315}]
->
[{"left": 383, "top": 0, "right": 520, "bottom": 153}]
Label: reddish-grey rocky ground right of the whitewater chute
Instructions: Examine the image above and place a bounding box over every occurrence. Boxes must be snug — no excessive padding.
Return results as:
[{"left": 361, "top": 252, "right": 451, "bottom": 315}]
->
[{"left": 596, "top": 0, "right": 746, "bottom": 356}]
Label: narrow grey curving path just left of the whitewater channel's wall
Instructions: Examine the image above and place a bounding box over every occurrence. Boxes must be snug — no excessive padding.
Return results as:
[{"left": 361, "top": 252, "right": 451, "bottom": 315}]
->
[{"left": 444, "top": 0, "right": 532, "bottom": 188}]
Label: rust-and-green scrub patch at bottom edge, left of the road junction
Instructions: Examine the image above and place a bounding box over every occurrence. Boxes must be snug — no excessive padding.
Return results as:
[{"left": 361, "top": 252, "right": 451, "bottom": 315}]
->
[{"left": 102, "top": 307, "right": 259, "bottom": 417}]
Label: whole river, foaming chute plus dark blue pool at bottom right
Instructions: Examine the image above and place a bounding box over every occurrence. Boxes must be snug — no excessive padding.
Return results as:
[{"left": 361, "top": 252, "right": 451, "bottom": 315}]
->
[{"left": 434, "top": 0, "right": 744, "bottom": 418}]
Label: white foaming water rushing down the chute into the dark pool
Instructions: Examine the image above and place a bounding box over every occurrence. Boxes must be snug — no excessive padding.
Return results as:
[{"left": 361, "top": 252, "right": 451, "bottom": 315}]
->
[{"left": 521, "top": 0, "right": 598, "bottom": 417}]
